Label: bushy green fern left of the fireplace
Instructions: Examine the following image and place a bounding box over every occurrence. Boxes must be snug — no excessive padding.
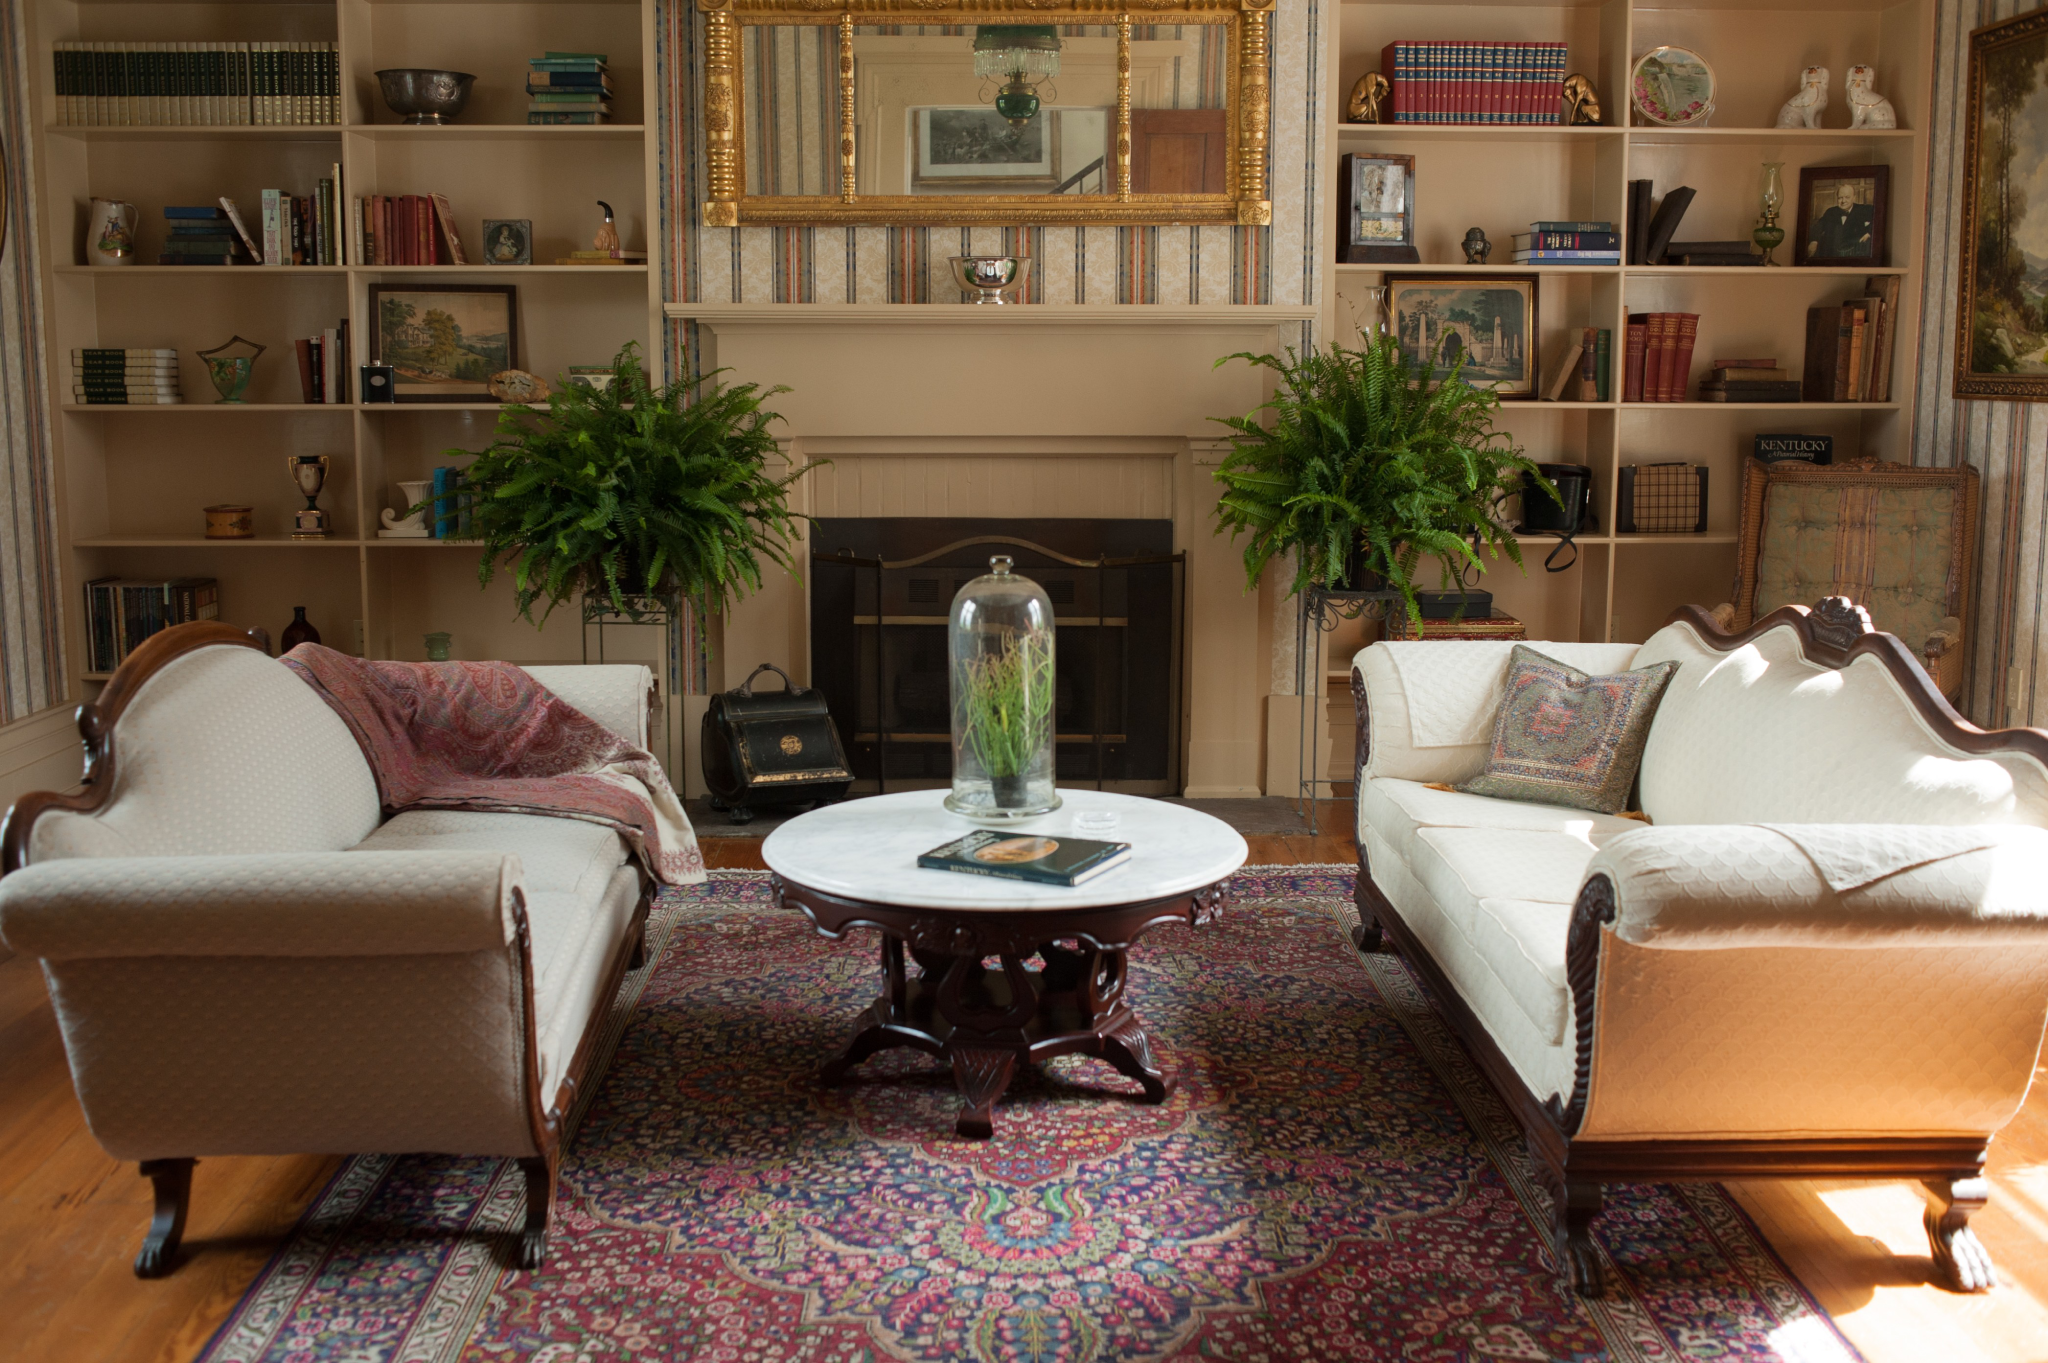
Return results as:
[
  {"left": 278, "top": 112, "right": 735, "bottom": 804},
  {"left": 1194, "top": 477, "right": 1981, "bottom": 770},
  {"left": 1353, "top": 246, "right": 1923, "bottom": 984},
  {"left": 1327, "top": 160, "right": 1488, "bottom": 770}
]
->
[{"left": 449, "top": 344, "right": 803, "bottom": 620}]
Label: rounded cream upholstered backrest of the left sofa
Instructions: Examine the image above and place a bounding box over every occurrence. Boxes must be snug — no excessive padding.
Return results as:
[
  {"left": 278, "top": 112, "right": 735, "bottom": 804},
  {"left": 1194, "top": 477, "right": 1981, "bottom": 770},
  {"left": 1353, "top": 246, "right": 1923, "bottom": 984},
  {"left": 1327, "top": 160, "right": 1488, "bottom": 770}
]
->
[{"left": 29, "top": 645, "right": 381, "bottom": 862}]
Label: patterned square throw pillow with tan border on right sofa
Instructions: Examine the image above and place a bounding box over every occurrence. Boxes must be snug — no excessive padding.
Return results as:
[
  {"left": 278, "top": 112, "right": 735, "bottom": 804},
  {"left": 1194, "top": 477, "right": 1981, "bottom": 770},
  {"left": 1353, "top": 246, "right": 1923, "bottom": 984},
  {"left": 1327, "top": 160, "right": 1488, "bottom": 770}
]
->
[{"left": 1458, "top": 645, "right": 1677, "bottom": 815}]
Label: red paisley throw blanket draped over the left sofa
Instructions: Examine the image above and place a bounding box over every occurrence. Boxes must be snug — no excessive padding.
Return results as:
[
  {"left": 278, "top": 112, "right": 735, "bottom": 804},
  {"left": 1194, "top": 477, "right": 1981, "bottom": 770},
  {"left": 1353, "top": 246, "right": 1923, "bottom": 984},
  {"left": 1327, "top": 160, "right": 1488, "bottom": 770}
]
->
[{"left": 285, "top": 645, "right": 705, "bottom": 884}]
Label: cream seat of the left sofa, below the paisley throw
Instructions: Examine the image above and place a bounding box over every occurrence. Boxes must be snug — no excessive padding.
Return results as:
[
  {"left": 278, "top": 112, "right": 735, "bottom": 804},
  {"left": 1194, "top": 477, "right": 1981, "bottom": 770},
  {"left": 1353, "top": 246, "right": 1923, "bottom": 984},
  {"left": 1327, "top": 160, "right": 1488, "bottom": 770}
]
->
[{"left": 352, "top": 808, "right": 631, "bottom": 1031}]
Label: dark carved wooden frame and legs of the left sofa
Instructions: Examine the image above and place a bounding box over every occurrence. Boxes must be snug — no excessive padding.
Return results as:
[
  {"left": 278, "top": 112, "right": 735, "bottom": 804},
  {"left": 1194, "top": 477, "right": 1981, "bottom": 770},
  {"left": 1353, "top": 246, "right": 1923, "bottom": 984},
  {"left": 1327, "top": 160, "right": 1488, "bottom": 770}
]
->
[{"left": 0, "top": 622, "right": 653, "bottom": 1277}]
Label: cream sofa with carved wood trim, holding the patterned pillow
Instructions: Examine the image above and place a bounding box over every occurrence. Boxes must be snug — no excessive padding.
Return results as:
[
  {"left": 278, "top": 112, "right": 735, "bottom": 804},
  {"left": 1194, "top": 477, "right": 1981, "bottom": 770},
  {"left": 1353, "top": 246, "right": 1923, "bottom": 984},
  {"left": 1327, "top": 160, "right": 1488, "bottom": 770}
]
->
[{"left": 1352, "top": 598, "right": 2048, "bottom": 1295}]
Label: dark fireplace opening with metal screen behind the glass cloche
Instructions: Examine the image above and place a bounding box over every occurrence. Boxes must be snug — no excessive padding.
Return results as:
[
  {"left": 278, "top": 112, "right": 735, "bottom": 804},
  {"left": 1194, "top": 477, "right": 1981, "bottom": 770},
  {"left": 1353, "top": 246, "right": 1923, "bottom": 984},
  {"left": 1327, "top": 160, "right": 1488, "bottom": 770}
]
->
[{"left": 809, "top": 516, "right": 1186, "bottom": 794}]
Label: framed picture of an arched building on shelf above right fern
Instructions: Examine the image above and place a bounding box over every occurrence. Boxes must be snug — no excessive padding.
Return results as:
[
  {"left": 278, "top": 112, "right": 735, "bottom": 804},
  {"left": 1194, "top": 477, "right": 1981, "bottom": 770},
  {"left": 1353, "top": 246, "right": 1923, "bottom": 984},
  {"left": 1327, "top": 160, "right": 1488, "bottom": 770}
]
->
[{"left": 1386, "top": 272, "right": 1538, "bottom": 401}]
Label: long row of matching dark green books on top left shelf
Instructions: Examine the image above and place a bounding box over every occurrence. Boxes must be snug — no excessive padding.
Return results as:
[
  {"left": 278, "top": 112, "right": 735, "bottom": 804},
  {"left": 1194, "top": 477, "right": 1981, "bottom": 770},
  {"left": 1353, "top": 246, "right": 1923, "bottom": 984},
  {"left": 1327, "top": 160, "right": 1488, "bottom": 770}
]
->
[{"left": 51, "top": 41, "right": 342, "bottom": 127}]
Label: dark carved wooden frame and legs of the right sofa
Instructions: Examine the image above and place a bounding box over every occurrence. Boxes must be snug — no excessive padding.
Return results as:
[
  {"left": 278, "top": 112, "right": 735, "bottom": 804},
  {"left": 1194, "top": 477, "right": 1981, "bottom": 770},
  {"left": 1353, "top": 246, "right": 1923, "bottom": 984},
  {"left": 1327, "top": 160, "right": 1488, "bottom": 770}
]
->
[{"left": 1352, "top": 596, "right": 2048, "bottom": 1298}]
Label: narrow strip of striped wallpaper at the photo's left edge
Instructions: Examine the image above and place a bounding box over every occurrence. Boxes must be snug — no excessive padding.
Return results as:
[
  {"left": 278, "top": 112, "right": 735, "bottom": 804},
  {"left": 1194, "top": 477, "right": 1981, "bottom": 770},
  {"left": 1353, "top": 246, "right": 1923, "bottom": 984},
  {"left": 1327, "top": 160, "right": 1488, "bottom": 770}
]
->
[{"left": 0, "top": 4, "right": 70, "bottom": 724}]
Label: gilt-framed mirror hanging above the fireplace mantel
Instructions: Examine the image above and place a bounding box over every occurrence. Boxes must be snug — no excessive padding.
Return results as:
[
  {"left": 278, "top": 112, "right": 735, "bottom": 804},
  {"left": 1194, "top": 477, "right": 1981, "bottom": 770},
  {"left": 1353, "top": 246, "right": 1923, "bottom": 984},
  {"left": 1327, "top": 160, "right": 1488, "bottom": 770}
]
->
[{"left": 698, "top": 0, "right": 1274, "bottom": 227}]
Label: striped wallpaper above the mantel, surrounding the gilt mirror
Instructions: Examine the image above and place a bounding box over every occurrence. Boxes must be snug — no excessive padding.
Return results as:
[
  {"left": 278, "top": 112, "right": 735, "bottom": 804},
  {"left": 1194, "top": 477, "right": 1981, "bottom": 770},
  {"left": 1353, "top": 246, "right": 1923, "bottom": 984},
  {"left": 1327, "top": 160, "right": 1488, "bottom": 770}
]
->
[{"left": 655, "top": 0, "right": 1329, "bottom": 349}]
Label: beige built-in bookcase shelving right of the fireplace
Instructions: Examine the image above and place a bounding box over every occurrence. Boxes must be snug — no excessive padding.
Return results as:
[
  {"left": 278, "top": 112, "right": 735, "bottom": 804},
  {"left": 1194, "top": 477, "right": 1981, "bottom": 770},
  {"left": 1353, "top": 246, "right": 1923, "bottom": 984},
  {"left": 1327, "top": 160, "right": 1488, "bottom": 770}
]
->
[{"left": 1321, "top": 0, "right": 1935, "bottom": 641}]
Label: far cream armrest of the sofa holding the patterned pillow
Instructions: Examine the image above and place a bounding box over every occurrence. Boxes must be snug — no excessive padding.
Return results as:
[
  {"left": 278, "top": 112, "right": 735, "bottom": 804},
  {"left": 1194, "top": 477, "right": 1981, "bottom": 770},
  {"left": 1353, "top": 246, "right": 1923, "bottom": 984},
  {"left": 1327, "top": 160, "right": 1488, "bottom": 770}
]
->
[{"left": 1352, "top": 639, "right": 1636, "bottom": 782}]
